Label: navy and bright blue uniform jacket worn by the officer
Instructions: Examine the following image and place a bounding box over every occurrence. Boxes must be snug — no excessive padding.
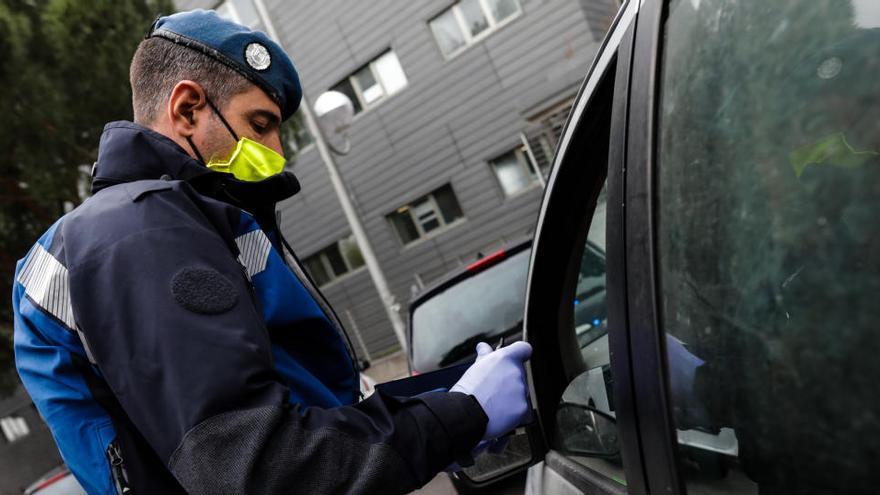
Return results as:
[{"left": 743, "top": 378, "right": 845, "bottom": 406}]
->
[{"left": 13, "top": 122, "right": 487, "bottom": 494}]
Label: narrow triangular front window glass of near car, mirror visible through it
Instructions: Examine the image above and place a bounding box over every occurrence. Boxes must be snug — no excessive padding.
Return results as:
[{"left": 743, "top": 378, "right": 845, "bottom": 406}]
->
[{"left": 550, "top": 182, "right": 625, "bottom": 484}]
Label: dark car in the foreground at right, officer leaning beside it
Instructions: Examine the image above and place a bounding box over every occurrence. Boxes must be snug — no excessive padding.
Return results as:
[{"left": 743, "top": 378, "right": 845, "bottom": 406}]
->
[{"left": 446, "top": 0, "right": 880, "bottom": 494}]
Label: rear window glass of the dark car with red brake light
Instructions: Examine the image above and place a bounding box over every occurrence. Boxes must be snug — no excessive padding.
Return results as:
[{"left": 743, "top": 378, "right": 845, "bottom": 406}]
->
[{"left": 412, "top": 248, "right": 531, "bottom": 372}]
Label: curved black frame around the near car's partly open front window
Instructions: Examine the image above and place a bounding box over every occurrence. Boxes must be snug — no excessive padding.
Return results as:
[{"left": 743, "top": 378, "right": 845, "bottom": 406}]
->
[{"left": 525, "top": 2, "right": 657, "bottom": 493}]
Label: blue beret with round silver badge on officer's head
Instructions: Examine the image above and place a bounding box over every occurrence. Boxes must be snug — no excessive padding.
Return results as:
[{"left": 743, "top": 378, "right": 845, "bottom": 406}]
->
[{"left": 147, "top": 9, "right": 302, "bottom": 120}]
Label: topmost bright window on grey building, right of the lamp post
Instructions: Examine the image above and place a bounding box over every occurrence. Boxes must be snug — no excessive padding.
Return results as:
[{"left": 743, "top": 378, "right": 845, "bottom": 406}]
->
[{"left": 428, "top": 0, "right": 522, "bottom": 58}]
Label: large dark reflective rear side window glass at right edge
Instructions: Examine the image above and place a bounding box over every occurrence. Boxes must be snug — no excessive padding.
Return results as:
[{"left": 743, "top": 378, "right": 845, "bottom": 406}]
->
[{"left": 657, "top": 0, "right": 880, "bottom": 494}]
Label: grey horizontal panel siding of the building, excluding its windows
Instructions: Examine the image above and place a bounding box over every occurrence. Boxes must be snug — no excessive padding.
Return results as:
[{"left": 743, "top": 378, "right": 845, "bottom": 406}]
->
[{"left": 177, "top": 0, "right": 616, "bottom": 354}]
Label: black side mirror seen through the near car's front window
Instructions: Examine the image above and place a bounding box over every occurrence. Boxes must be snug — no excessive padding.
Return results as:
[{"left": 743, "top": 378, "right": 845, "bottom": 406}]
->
[{"left": 554, "top": 402, "right": 620, "bottom": 459}]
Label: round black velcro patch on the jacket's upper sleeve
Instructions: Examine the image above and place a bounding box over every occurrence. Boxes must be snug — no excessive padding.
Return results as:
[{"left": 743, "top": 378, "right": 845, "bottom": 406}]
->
[{"left": 171, "top": 267, "right": 238, "bottom": 315}]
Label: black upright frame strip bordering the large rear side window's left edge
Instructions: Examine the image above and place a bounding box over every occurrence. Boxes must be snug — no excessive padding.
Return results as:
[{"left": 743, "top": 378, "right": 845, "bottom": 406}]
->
[{"left": 624, "top": 0, "right": 686, "bottom": 494}]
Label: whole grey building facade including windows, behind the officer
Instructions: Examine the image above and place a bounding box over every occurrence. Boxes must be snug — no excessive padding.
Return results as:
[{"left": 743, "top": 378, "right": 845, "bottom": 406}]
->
[{"left": 177, "top": 0, "right": 619, "bottom": 358}]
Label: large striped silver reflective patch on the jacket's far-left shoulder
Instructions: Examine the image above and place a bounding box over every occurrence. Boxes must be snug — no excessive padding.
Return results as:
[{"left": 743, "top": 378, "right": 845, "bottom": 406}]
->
[{"left": 16, "top": 244, "right": 95, "bottom": 363}]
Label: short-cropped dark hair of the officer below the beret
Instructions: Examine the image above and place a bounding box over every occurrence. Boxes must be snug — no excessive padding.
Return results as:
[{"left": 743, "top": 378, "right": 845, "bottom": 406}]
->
[{"left": 129, "top": 37, "right": 251, "bottom": 125}]
